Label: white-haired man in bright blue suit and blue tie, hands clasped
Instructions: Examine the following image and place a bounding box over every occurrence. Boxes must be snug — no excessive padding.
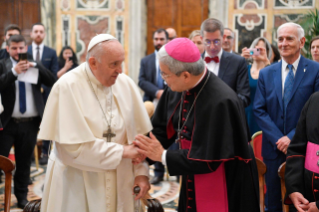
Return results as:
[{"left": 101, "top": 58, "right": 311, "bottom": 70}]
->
[{"left": 253, "top": 23, "right": 319, "bottom": 212}]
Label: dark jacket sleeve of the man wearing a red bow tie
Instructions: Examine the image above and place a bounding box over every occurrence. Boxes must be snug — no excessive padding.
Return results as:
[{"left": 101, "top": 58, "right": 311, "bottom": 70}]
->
[{"left": 236, "top": 58, "right": 250, "bottom": 107}]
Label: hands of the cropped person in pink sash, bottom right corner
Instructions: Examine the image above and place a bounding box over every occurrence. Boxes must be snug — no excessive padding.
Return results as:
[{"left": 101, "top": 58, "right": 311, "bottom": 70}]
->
[{"left": 289, "top": 192, "right": 319, "bottom": 212}]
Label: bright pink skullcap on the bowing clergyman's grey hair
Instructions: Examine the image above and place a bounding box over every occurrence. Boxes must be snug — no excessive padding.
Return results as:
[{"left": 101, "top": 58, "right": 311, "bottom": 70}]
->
[{"left": 164, "top": 38, "right": 201, "bottom": 63}]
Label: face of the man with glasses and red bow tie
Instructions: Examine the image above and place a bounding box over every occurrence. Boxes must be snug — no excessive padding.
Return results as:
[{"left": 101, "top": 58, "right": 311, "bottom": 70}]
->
[{"left": 203, "top": 30, "right": 223, "bottom": 57}]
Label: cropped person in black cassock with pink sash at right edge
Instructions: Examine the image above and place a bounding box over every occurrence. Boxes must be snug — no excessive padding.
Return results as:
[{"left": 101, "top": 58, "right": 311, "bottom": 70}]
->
[{"left": 285, "top": 92, "right": 319, "bottom": 212}]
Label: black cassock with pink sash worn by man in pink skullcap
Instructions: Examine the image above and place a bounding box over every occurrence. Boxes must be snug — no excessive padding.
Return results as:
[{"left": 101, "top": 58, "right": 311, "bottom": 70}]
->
[{"left": 152, "top": 72, "right": 259, "bottom": 212}]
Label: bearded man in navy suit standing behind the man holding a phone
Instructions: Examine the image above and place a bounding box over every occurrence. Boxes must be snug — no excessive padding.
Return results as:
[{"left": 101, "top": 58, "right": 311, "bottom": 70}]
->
[{"left": 28, "top": 23, "right": 59, "bottom": 165}]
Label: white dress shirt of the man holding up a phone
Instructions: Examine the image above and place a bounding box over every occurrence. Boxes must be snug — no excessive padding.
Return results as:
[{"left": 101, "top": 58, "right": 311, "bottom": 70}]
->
[{"left": 10, "top": 57, "right": 39, "bottom": 118}]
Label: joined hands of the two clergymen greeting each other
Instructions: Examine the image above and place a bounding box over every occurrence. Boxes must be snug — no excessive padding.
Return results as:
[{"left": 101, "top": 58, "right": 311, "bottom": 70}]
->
[{"left": 122, "top": 133, "right": 164, "bottom": 164}]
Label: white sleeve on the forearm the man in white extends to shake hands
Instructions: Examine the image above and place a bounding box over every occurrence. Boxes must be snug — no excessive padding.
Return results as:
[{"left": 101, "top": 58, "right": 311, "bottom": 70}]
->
[{"left": 55, "top": 139, "right": 124, "bottom": 172}]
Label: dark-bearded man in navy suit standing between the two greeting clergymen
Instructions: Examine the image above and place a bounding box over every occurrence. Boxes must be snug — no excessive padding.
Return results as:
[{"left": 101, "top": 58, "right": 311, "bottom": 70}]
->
[{"left": 138, "top": 29, "right": 168, "bottom": 184}]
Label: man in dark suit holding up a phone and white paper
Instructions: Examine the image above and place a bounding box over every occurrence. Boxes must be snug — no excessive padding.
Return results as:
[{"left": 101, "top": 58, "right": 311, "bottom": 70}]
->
[{"left": 0, "top": 35, "right": 56, "bottom": 208}]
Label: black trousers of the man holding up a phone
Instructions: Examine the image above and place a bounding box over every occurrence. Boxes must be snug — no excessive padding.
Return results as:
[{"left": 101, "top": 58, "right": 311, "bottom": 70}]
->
[{"left": 0, "top": 117, "right": 40, "bottom": 202}]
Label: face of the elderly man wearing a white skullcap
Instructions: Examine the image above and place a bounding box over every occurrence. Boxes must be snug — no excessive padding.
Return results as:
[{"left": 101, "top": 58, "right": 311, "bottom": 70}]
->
[{"left": 89, "top": 41, "right": 125, "bottom": 87}]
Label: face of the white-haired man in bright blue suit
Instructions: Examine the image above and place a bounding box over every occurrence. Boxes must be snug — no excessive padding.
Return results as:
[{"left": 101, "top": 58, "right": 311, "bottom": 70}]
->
[{"left": 278, "top": 26, "right": 305, "bottom": 62}]
